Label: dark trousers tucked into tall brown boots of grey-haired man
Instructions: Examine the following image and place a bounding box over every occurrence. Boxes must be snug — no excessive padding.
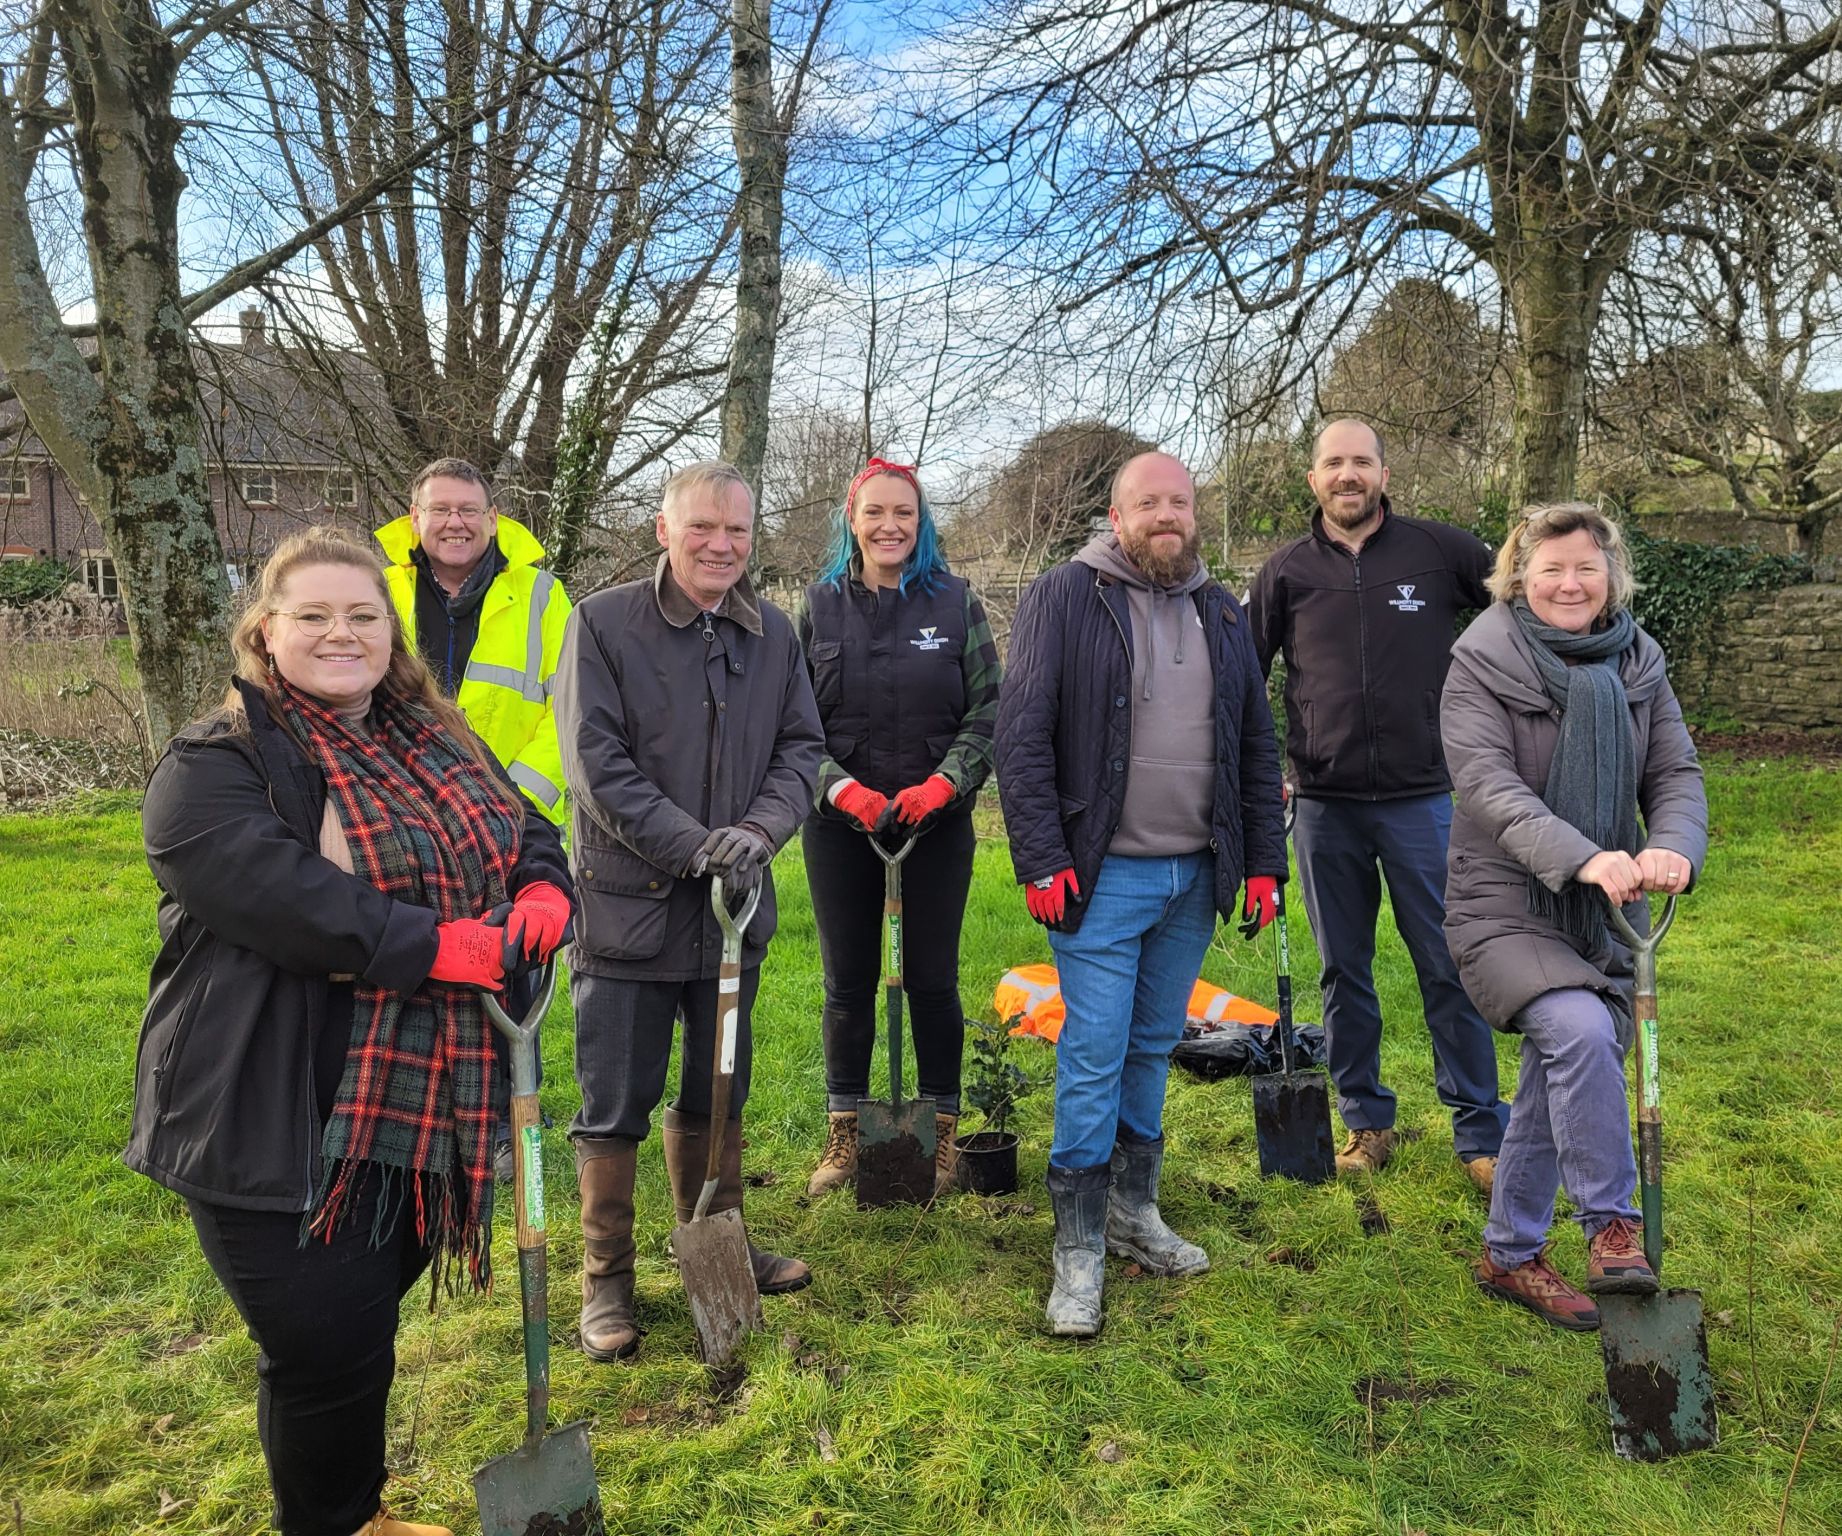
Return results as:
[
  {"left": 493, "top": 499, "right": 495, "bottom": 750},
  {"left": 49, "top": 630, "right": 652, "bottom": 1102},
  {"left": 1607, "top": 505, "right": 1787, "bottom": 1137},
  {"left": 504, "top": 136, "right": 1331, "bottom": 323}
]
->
[{"left": 569, "top": 965, "right": 761, "bottom": 1142}]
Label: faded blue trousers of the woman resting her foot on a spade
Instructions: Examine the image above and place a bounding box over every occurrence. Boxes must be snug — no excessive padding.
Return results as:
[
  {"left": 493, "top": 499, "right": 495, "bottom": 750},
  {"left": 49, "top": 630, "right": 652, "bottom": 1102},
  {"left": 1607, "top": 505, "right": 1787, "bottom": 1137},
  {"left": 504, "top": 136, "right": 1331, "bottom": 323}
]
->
[{"left": 1485, "top": 987, "right": 1638, "bottom": 1269}]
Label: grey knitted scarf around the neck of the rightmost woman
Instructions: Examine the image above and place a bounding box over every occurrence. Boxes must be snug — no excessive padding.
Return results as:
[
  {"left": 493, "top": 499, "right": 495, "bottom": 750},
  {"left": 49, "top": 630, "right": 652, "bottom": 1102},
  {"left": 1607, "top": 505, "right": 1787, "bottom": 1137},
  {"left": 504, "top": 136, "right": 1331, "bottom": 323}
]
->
[{"left": 1510, "top": 597, "right": 1639, "bottom": 948}]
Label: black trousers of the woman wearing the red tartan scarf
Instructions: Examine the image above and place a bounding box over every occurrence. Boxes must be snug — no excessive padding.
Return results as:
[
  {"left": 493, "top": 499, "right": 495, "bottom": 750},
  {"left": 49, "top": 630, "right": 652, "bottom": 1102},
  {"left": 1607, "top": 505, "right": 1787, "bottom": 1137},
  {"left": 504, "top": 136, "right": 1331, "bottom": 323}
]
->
[{"left": 186, "top": 1179, "right": 429, "bottom": 1536}]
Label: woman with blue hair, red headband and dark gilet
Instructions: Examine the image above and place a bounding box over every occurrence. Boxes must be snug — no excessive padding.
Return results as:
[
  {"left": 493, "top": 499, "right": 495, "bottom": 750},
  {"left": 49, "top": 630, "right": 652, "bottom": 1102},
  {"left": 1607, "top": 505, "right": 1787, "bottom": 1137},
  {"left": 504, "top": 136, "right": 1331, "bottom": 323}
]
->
[{"left": 798, "top": 459, "right": 998, "bottom": 1195}]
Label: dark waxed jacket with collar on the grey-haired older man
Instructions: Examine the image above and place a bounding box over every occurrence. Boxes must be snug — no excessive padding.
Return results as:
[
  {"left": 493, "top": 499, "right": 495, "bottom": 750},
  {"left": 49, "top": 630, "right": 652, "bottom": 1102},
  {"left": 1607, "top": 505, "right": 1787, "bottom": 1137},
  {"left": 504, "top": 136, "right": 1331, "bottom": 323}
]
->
[{"left": 556, "top": 556, "right": 823, "bottom": 982}]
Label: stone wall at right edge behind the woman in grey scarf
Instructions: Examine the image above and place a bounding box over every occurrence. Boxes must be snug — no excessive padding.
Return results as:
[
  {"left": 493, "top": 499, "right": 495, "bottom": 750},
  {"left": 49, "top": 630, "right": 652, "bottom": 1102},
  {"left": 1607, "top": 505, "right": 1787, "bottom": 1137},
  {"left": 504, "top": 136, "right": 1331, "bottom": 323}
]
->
[{"left": 1671, "top": 584, "right": 1842, "bottom": 731}]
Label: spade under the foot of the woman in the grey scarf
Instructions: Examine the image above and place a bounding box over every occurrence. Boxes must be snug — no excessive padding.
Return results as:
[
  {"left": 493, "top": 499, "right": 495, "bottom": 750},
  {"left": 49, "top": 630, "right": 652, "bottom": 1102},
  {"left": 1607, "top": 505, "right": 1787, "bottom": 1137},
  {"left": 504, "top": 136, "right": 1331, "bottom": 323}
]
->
[{"left": 1593, "top": 897, "right": 1720, "bottom": 1460}]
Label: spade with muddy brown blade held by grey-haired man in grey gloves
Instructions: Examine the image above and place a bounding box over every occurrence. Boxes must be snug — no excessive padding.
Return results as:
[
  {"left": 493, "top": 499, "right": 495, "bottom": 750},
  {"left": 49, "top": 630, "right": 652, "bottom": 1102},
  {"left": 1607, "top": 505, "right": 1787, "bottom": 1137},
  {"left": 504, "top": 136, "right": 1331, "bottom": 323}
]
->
[{"left": 672, "top": 877, "right": 761, "bottom": 1368}]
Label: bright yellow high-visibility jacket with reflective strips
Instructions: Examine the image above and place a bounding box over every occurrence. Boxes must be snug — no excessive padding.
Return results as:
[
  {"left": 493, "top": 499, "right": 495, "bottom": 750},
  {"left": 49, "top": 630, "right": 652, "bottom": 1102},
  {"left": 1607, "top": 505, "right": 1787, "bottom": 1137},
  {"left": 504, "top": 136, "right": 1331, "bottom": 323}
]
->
[{"left": 376, "top": 514, "right": 569, "bottom": 827}]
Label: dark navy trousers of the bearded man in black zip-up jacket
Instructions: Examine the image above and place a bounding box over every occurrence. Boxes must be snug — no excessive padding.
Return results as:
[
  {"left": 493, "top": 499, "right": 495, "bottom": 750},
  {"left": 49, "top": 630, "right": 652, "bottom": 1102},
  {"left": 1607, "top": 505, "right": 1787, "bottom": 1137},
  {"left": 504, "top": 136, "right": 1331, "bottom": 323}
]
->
[{"left": 1295, "top": 794, "right": 1509, "bottom": 1162}]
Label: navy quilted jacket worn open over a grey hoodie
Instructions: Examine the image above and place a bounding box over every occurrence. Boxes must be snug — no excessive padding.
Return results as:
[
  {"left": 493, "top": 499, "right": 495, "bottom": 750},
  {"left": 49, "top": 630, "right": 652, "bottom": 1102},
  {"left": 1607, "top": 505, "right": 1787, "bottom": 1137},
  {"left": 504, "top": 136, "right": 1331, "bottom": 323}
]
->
[{"left": 998, "top": 562, "right": 1286, "bottom": 932}]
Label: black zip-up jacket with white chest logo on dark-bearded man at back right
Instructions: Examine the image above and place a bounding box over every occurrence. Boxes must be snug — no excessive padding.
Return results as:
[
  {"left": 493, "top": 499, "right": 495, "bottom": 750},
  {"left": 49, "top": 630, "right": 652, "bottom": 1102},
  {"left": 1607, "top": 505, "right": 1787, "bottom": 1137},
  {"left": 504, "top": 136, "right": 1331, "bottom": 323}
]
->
[{"left": 1247, "top": 497, "right": 1492, "bottom": 799}]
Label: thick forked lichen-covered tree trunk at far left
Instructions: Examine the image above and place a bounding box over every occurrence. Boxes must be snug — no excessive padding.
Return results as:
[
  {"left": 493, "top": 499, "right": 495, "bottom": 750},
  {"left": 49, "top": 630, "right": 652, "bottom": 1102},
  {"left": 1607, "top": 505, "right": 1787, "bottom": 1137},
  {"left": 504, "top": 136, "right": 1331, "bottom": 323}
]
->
[{"left": 0, "top": 0, "right": 230, "bottom": 744}]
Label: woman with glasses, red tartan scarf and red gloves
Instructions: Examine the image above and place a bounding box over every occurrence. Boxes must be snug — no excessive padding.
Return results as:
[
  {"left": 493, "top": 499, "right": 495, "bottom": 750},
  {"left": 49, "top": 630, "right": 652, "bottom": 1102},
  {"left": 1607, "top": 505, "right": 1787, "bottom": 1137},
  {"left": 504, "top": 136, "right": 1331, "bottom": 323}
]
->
[{"left": 125, "top": 530, "right": 571, "bottom": 1536}]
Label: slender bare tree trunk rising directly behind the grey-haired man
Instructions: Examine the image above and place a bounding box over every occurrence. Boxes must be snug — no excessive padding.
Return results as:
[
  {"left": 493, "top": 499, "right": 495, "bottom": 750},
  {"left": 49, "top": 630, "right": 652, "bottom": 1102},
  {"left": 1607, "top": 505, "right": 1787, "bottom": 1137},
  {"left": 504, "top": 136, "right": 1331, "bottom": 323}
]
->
[{"left": 722, "top": 0, "right": 787, "bottom": 503}]
